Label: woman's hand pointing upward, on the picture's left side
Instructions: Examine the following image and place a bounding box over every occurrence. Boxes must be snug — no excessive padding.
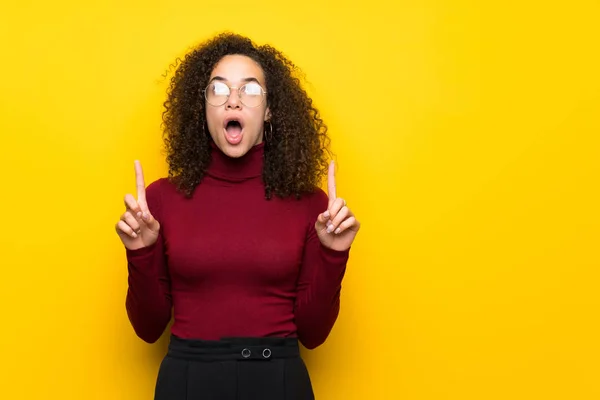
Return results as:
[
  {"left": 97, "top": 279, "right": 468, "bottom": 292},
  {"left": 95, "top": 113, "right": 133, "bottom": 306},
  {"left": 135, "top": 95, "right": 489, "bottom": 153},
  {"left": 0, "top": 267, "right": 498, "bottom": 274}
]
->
[{"left": 115, "top": 161, "right": 160, "bottom": 250}]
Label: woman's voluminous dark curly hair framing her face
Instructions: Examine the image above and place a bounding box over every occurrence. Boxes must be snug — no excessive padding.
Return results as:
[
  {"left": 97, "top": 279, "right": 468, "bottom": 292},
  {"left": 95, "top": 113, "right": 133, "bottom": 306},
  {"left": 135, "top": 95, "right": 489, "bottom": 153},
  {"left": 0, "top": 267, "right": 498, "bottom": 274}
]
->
[{"left": 162, "top": 32, "right": 330, "bottom": 199}]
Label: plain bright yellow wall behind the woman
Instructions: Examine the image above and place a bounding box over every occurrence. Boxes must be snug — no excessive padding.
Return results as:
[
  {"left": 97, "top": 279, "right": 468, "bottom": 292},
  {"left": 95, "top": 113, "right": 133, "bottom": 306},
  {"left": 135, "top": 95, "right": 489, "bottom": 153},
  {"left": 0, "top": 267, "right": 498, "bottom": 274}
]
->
[{"left": 0, "top": 0, "right": 600, "bottom": 400}]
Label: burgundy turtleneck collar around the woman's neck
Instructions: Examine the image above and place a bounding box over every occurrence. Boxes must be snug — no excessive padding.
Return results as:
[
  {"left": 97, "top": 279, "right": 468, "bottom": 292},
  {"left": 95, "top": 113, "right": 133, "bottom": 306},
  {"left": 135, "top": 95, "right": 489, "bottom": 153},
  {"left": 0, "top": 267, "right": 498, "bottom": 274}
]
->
[{"left": 206, "top": 141, "right": 265, "bottom": 182}]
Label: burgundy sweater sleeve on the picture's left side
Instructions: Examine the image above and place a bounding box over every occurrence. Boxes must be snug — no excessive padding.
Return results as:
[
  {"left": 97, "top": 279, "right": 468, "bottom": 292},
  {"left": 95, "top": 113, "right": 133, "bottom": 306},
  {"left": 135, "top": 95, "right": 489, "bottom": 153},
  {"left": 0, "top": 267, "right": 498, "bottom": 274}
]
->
[{"left": 125, "top": 181, "right": 172, "bottom": 343}]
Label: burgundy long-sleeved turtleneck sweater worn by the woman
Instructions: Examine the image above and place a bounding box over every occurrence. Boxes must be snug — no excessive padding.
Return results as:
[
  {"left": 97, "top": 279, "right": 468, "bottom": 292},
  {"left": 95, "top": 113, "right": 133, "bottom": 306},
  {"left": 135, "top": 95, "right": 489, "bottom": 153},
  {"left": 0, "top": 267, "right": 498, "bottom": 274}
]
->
[{"left": 126, "top": 142, "right": 350, "bottom": 349}]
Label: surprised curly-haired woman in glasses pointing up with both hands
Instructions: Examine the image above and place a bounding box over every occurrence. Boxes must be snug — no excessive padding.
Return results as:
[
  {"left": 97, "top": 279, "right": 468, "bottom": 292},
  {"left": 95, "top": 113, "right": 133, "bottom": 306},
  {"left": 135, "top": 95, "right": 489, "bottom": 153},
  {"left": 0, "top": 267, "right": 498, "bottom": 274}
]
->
[{"left": 116, "top": 34, "right": 360, "bottom": 400}]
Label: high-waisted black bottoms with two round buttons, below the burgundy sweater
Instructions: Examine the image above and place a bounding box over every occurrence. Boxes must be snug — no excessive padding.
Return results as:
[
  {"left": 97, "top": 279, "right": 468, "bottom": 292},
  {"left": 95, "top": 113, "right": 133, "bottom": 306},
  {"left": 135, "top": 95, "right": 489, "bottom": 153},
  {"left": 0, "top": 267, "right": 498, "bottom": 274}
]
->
[{"left": 154, "top": 335, "right": 315, "bottom": 400}]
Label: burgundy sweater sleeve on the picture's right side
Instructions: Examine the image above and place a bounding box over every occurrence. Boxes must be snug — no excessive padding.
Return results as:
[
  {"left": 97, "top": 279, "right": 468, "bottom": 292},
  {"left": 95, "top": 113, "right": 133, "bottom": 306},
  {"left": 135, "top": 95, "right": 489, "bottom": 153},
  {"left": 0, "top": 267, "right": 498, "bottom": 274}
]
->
[{"left": 294, "top": 190, "right": 350, "bottom": 349}]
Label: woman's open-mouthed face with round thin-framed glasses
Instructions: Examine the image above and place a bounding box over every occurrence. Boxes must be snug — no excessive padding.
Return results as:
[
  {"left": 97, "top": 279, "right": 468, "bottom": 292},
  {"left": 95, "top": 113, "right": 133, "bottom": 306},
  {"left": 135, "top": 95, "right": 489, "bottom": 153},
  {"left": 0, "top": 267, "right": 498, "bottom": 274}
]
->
[{"left": 205, "top": 55, "right": 270, "bottom": 157}]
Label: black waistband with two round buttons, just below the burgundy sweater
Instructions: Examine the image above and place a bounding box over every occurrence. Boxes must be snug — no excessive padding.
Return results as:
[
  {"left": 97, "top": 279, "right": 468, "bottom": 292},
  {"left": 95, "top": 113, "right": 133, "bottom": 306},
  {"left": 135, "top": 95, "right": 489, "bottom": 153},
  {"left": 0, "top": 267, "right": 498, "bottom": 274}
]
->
[{"left": 167, "top": 334, "right": 300, "bottom": 361}]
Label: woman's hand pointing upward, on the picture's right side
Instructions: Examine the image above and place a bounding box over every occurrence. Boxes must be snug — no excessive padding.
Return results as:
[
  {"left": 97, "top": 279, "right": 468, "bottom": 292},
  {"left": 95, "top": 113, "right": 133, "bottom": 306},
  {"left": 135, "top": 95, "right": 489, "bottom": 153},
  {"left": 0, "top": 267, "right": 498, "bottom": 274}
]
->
[{"left": 315, "top": 161, "right": 360, "bottom": 251}]
